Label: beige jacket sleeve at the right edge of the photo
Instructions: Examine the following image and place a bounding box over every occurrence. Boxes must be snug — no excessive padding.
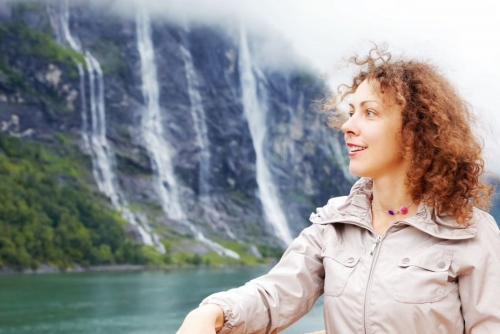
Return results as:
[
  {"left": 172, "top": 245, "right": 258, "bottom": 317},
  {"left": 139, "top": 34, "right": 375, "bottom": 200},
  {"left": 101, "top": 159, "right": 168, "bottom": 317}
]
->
[{"left": 458, "top": 212, "right": 500, "bottom": 334}]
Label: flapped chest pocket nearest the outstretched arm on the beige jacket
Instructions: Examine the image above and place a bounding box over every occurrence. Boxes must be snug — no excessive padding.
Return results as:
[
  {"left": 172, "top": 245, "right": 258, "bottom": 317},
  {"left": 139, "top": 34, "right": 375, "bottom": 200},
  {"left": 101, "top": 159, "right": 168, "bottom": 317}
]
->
[{"left": 321, "top": 245, "right": 362, "bottom": 296}]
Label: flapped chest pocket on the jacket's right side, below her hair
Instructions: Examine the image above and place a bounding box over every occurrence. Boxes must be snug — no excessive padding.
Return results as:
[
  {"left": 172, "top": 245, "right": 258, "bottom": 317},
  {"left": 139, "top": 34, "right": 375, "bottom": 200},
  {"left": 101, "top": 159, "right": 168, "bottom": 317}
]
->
[{"left": 392, "top": 247, "right": 452, "bottom": 304}]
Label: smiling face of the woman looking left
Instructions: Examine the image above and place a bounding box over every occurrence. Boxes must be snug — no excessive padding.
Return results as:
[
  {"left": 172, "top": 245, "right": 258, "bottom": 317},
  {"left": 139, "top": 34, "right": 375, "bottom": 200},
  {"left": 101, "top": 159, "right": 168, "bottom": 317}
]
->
[{"left": 341, "top": 80, "right": 408, "bottom": 179}]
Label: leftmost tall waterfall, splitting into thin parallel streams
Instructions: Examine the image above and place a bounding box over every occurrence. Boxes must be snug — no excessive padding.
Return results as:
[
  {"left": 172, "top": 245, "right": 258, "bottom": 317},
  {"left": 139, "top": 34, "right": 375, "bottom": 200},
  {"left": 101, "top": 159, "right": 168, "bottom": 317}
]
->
[{"left": 48, "top": 0, "right": 165, "bottom": 253}]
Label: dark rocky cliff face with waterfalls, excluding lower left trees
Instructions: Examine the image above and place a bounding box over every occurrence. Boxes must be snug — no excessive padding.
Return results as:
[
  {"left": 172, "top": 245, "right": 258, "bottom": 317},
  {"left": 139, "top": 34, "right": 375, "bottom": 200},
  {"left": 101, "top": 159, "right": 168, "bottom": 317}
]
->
[{"left": 0, "top": 1, "right": 353, "bottom": 255}]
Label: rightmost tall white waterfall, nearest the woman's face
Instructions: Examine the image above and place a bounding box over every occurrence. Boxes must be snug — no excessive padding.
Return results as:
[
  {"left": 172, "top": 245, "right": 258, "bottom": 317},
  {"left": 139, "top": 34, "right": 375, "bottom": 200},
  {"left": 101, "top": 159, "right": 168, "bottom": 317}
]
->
[{"left": 238, "top": 28, "right": 292, "bottom": 244}]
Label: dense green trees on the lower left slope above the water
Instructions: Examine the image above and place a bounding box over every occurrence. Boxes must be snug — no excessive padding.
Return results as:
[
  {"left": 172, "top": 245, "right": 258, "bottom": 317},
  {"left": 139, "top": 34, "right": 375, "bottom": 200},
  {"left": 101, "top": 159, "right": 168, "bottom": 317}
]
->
[{"left": 0, "top": 134, "right": 156, "bottom": 268}]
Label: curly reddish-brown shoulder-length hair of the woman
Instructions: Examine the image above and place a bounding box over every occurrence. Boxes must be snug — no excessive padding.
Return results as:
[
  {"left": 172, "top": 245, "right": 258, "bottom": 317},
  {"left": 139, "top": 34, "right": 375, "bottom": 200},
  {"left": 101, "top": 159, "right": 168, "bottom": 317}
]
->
[{"left": 324, "top": 46, "right": 493, "bottom": 226}]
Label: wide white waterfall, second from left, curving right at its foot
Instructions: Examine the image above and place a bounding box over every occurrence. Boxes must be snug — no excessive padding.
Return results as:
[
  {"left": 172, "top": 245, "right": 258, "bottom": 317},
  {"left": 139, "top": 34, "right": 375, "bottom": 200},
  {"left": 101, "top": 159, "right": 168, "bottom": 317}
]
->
[{"left": 136, "top": 9, "right": 239, "bottom": 259}]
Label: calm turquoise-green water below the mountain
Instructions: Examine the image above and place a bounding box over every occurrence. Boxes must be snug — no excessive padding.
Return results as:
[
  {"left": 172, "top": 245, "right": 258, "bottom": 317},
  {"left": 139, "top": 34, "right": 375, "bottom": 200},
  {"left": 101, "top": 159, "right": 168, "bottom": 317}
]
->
[{"left": 0, "top": 267, "right": 323, "bottom": 334}]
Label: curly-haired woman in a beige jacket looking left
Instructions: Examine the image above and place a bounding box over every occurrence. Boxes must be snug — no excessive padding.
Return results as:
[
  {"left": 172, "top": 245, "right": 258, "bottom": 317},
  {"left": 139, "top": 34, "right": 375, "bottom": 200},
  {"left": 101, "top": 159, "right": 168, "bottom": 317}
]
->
[{"left": 178, "top": 49, "right": 500, "bottom": 334}]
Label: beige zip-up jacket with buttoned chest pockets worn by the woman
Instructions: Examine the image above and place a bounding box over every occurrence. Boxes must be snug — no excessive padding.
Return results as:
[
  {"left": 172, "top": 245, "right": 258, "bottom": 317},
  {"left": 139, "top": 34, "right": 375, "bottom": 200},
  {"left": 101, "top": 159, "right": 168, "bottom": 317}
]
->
[{"left": 203, "top": 179, "right": 500, "bottom": 334}]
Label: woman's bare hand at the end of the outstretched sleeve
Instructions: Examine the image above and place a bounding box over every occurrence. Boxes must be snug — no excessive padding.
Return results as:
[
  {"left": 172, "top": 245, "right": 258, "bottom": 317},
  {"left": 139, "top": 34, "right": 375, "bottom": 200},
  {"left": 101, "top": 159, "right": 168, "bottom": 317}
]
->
[{"left": 177, "top": 304, "right": 224, "bottom": 334}]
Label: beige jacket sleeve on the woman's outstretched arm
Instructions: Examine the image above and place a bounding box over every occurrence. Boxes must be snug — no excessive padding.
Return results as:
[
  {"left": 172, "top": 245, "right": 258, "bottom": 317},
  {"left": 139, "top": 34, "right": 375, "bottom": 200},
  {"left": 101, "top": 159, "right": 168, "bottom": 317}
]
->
[{"left": 202, "top": 224, "right": 325, "bottom": 334}]
